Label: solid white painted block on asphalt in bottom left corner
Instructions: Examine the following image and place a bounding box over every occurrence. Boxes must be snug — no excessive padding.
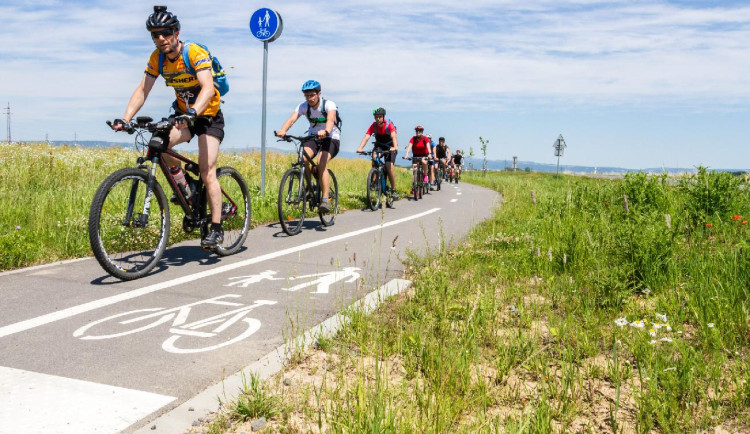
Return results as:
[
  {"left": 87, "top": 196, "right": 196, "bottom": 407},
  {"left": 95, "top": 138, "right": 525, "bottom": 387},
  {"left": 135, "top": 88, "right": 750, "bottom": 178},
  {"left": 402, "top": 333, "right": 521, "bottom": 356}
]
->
[{"left": 0, "top": 366, "right": 177, "bottom": 434}]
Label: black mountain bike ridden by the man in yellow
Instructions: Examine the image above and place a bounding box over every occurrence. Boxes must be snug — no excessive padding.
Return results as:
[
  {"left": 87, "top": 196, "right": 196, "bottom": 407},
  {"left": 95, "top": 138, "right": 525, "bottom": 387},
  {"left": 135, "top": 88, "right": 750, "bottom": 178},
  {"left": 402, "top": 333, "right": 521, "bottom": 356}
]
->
[{"left": 88, "top": 116, "right": 251, "bottom": 280}]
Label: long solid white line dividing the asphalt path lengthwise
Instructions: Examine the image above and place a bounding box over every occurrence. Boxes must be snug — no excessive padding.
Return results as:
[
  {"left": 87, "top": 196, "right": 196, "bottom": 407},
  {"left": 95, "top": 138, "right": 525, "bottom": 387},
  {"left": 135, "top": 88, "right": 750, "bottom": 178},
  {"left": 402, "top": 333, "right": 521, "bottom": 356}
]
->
[{"left": 0, "top": 208, "right": 440, "bottom": 338}]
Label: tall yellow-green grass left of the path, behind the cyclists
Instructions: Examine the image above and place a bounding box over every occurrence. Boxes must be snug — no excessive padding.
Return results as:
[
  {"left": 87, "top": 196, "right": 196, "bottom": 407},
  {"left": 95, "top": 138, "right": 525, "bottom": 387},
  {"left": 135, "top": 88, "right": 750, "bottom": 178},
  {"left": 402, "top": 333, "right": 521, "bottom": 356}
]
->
[{"left": 0, "top": 143, "right": 409, "bottom": 271}]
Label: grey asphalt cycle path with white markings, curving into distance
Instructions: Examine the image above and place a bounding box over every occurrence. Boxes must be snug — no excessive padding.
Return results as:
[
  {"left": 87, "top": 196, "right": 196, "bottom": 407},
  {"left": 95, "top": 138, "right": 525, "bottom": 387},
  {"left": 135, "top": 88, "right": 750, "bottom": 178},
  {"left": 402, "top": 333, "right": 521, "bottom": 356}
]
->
[{"left": 0, "top": 179, "right": 501, "bottom": 433}]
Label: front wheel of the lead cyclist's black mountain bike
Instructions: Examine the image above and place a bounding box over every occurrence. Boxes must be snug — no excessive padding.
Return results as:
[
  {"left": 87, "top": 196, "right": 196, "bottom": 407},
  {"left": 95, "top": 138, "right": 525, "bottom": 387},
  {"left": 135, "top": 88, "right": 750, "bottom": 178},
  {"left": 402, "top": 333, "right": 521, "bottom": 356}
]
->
[{"left": 89, "top": 168, "right": 169, "bottom": 280}]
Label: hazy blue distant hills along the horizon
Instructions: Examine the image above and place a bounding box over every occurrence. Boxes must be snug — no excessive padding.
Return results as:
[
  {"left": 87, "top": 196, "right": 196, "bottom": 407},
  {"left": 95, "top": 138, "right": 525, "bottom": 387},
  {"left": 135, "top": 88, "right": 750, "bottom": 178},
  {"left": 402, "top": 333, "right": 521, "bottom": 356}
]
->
[{"left": 29, "top": 140, "right": 747, "bottom": 175}]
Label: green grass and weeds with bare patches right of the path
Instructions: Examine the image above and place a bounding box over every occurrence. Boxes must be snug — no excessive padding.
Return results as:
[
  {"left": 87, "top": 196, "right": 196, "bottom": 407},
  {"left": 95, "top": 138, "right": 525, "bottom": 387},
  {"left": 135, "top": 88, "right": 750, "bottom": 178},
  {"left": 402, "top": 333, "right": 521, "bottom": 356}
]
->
[{"left": 198, "top": 169, "right": 750, "bottom": 433}]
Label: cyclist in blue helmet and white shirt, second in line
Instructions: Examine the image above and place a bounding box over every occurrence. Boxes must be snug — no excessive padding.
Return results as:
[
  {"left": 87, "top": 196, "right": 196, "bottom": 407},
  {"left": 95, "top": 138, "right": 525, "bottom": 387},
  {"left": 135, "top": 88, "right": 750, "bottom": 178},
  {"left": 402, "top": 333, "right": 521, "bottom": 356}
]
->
[{"left": 276, "top": 80, "right": 341, "bottom": 212}]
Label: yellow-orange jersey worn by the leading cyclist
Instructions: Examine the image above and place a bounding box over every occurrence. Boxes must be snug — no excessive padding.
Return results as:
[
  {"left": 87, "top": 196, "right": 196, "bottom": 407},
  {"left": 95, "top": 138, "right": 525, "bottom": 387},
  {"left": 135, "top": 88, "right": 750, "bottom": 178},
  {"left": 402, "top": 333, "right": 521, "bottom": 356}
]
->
[{"left": 145, "top": 43, "right": 221, "bottom": 116}]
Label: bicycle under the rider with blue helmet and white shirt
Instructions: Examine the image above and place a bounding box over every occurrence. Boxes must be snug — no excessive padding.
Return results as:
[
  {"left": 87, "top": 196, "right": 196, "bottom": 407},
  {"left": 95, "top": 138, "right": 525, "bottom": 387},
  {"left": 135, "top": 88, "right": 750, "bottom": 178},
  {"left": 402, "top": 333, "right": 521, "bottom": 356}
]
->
[{"left": 274, "top": 131, "right": 339, "bottom": 236}]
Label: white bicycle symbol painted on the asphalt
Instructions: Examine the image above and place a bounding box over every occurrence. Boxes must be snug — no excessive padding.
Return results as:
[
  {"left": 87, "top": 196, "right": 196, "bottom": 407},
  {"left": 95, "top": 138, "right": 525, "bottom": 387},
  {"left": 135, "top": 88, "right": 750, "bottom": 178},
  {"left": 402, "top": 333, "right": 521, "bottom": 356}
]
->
[{"left": 73, "top": 294, "right": 276, "bottom": 354}]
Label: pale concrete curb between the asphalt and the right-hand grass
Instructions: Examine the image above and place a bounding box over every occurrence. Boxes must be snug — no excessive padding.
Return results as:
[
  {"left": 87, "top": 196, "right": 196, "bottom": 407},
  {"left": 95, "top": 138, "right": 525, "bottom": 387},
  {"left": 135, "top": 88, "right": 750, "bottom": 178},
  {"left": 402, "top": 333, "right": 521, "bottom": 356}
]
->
[{"left": 136, "top": 279, "right": 418, "bottom": 434}]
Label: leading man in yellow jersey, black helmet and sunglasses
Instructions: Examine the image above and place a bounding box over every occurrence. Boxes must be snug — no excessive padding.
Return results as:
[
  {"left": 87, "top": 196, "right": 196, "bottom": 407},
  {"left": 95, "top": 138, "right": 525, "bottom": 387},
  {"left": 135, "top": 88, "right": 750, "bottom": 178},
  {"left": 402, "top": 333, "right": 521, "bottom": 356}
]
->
[{"left": 112, "top": 6, "right": 224, "bottom": 251}]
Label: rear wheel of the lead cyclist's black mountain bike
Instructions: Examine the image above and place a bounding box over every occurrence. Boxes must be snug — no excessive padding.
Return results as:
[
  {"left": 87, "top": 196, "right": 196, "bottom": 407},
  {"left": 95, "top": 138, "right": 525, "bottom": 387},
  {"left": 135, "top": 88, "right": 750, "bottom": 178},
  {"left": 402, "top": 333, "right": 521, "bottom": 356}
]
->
[{"left": 214, "top": 167, "right": 252, "bottom": 256}]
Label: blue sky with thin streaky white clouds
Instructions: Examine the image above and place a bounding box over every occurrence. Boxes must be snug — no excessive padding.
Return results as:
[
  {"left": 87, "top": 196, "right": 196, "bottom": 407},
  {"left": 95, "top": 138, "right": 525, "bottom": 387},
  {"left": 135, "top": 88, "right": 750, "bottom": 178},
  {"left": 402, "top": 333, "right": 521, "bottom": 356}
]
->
[{"left": 0, "top": 0, "right": 750, "bottom": 169}]
